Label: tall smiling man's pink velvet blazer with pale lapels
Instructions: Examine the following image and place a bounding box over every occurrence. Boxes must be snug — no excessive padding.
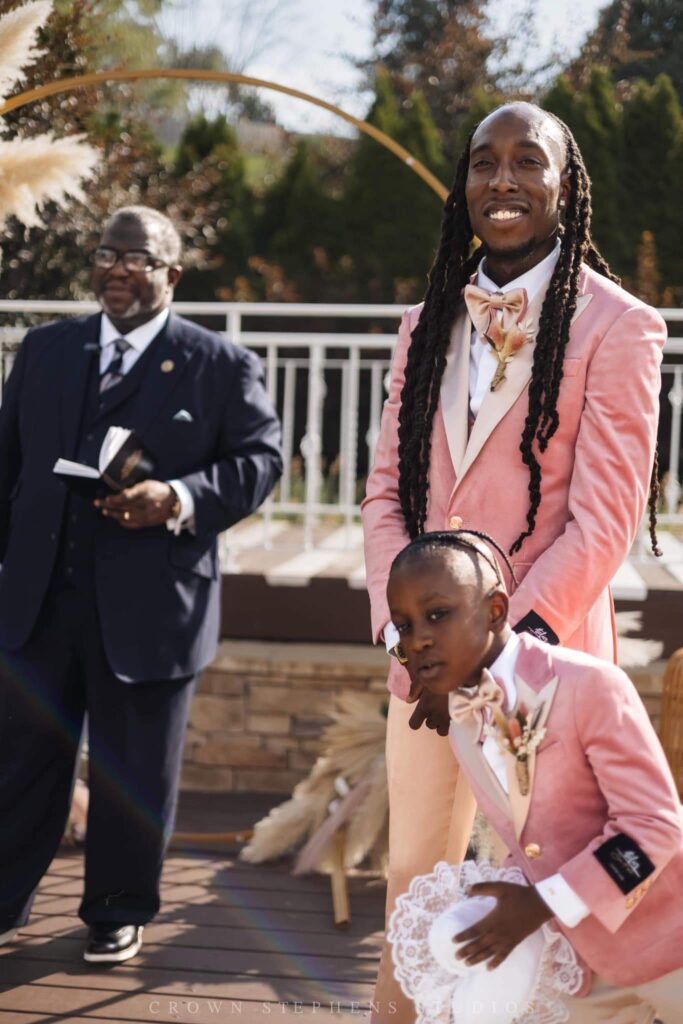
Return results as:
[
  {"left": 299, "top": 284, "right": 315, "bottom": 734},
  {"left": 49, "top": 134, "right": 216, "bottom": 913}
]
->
[{"left": 362, "top": 267, "right": 667, "bottom": 697}]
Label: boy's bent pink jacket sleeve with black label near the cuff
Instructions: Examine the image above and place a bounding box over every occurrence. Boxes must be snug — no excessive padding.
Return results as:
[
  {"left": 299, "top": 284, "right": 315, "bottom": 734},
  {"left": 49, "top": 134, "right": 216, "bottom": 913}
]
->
[{"left": 559, "top": 665, "right": 683, "bottom": 932}]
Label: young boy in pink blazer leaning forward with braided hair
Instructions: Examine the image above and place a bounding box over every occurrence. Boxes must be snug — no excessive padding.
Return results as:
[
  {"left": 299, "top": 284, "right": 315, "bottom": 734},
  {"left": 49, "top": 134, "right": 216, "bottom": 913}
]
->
[{"left": 387, "top": 530, "right": 683, "bottom": 1024}]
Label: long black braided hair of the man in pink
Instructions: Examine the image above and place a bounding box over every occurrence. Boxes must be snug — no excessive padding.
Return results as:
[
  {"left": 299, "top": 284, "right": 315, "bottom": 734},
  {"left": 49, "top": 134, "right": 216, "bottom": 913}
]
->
[{"left": 398, "top": 104, "right": 660, "bottom": 555}]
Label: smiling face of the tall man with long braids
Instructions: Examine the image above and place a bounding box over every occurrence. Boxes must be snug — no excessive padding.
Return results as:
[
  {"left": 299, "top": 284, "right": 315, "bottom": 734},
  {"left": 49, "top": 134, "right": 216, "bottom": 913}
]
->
[{"left": 465, "top": 103, "right": 569, "bottom": 265}]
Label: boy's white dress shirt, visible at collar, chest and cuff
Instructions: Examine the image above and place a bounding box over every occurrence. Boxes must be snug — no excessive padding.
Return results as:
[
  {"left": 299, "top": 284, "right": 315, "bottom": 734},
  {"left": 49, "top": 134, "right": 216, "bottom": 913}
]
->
[{"left": 481, "top": 633, "right": 591, "bottom": 928}]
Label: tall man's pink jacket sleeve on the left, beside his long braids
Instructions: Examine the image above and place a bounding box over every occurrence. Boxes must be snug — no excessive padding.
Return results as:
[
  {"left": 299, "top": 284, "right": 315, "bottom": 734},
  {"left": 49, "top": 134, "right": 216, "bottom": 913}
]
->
[{"left": 360, "top": 310, "right": 419, "bottom": 643}]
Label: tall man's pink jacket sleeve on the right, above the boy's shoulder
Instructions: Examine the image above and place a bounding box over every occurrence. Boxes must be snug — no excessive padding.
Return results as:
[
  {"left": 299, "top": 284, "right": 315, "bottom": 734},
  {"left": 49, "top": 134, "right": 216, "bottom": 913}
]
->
[{"left": 510, "top": 306, "right": 667, "bottom": 641}]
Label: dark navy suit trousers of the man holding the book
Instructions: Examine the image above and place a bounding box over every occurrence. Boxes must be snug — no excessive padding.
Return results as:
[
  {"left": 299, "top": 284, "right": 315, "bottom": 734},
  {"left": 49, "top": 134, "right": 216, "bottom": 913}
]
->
[{"left": 0, "top": 587, "right": 196, "bottom": 932}]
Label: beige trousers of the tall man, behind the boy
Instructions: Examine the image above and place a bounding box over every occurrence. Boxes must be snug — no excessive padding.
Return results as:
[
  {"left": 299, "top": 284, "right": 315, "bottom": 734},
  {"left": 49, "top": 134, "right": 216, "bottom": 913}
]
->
[{"left": 372, "top": 696, "right": 476, "bottom": 1024}]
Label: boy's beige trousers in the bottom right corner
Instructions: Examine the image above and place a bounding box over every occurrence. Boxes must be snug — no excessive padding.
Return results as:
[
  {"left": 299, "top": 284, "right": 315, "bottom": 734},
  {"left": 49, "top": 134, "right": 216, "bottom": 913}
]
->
[{"left": 566, "top": 966, "right": 683, "bottom": 1024}]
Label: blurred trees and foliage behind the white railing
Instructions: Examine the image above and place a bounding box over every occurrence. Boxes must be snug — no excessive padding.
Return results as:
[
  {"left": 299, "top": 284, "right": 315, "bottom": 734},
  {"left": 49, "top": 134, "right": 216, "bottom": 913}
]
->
[{"left": 0, "top": 0, "right": 683, "bottom": 305}]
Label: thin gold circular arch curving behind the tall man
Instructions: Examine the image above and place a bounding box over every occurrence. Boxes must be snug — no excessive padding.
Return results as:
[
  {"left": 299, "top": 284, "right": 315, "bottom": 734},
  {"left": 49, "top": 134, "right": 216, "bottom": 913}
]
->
[{"left": 0, "top": 68, "right": 449, "bottom": 201}]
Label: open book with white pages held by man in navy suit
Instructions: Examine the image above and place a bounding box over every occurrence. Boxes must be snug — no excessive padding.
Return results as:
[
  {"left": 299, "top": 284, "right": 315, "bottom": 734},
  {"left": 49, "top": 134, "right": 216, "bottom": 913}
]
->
[{"left": 52, "top": 427, "right": 155, "bottom": 496}]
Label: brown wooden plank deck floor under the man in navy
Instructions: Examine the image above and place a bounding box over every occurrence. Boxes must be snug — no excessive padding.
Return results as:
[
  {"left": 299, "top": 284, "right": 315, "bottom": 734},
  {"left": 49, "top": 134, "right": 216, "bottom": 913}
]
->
[{"left": 0, "top": 794, "right": 385, "bottom": 1024}]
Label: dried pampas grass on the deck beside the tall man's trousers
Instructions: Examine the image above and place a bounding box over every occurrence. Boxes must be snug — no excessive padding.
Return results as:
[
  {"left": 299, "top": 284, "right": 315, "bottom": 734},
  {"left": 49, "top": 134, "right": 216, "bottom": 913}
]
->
[{"left": 240, "top": 693, "right": 388, "bottom": 871}]
